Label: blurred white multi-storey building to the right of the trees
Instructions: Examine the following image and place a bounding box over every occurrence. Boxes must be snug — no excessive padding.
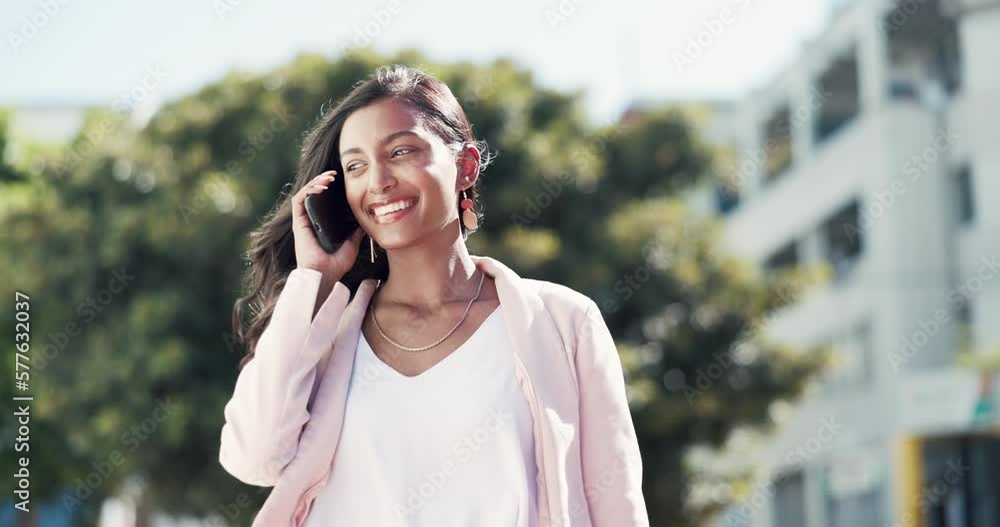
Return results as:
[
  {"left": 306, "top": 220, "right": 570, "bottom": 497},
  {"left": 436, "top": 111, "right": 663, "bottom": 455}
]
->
[{"left": 717, "top": 0, "right": 1000, "bottom": 527}]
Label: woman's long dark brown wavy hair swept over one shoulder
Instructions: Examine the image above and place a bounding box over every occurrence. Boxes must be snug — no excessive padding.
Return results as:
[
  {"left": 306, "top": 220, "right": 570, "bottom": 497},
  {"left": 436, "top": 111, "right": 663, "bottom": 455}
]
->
[{"left": 233, "top": 64, "right": 492, "bottom": 369}]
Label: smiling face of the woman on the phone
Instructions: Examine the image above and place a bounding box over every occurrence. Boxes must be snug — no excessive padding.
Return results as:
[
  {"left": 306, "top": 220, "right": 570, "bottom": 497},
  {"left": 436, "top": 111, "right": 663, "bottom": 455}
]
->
[{"left": 338, "top": 99, "right": 468, "bottom": 249}]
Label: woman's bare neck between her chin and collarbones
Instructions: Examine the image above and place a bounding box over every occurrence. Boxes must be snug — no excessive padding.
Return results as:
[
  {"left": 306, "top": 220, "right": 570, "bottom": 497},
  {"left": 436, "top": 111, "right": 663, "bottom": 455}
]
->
[{"left": 378, "top": 224, "right": 485, "bottom": 312}]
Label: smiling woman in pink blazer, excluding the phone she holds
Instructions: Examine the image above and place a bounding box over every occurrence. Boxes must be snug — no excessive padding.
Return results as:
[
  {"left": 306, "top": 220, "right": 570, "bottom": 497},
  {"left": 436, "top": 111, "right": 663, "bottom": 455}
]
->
[{"left": 219, "top": 66, "right": 648, "bottom": 527}]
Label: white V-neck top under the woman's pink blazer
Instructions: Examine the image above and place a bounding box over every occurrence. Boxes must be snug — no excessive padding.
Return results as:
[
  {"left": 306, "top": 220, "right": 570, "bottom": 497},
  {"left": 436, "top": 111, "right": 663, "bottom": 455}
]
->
[{"left": 305, "top": 307, "right": 538, "bottom": 527}]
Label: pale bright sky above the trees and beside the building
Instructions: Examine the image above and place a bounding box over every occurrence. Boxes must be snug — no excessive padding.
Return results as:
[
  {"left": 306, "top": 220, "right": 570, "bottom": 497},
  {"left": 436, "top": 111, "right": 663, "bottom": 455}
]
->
[{"left": 0, "top": 0, "right": 830, "bottom": 125}]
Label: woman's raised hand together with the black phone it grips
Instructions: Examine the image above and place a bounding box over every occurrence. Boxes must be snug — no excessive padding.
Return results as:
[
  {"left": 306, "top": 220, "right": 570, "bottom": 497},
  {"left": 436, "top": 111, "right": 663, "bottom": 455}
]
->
[{"left": 292, "top": 170, "right": 364, "bottom": 280}]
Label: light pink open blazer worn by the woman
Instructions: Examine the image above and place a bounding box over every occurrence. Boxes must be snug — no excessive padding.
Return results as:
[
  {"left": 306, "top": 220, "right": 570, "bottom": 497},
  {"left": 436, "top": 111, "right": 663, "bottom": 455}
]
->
[{"left": 219, "top": 256, "right": 649, "bottom": 527}]
